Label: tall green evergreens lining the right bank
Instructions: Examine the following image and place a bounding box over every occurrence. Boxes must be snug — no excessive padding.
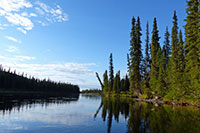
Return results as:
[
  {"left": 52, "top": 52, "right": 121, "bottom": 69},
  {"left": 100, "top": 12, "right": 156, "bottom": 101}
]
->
[{"left": 103, "top": 0, "right": 200, "bottom": 103}]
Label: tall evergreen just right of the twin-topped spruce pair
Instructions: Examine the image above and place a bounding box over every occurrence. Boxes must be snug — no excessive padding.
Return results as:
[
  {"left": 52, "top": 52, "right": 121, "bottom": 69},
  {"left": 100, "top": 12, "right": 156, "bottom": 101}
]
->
[{"left": 149, "top": 18, "right": 161, "bottom": 94}]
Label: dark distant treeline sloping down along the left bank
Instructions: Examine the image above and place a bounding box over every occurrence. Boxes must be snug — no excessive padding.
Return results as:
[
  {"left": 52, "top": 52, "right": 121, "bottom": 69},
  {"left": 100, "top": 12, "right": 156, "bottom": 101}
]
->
[{"left": 0, "top": 65, "right": 80, "bottom": 93}]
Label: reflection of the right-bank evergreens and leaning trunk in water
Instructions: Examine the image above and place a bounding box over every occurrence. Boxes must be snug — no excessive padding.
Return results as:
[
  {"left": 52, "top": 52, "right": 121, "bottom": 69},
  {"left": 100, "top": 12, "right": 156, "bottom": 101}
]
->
[{"left": 97, "top": 97, "right": 200, "bottom": 133}]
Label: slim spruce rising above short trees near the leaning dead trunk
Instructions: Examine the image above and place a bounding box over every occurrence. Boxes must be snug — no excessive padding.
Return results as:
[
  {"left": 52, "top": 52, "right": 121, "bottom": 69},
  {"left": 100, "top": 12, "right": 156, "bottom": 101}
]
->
[{"left": 109, "top": 53, "right": 114, "bottom": 92}]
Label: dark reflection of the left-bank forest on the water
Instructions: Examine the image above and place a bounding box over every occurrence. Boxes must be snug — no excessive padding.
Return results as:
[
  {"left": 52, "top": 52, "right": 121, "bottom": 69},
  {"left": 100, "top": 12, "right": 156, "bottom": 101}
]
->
[{"left": 0, "top": 94, "right": 79, "bottom": 115}]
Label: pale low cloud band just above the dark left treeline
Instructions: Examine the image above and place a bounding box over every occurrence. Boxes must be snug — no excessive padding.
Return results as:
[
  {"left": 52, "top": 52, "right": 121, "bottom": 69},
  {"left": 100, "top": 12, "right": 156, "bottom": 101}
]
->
[{"left": 0, "top": 56, "right": 99, "bottom": 88}]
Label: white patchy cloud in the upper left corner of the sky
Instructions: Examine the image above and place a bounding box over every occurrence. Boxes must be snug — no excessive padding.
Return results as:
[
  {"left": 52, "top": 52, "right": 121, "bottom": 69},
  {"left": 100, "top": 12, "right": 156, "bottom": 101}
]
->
[{"left": 0, "top": 0, "right": 68, "bottom": 34}]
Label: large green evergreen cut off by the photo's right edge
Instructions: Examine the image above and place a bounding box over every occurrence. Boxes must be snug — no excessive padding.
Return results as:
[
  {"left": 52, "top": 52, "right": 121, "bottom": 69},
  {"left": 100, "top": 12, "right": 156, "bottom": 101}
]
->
[{"left": 185, "top": 0, "right": 200, "bottom": 98}]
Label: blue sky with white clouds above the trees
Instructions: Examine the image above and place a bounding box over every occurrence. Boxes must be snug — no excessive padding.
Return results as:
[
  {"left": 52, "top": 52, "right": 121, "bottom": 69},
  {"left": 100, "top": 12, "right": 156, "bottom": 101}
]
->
[{"left": 0, "top": 0, "right": 186, "bottom": 89}]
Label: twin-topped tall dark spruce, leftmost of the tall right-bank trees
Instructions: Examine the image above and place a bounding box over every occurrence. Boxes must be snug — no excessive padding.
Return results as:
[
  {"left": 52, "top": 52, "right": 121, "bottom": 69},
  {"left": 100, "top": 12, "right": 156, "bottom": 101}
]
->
[{"left": 130, "top": 17, "right": 142, "bottom": 95}]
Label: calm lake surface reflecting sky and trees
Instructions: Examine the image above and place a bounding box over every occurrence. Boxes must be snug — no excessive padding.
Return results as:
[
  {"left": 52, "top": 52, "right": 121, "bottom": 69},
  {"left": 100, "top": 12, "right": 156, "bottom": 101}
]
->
[{"left": 0, "top": 95, "right": 200, "bottom": 133}]
